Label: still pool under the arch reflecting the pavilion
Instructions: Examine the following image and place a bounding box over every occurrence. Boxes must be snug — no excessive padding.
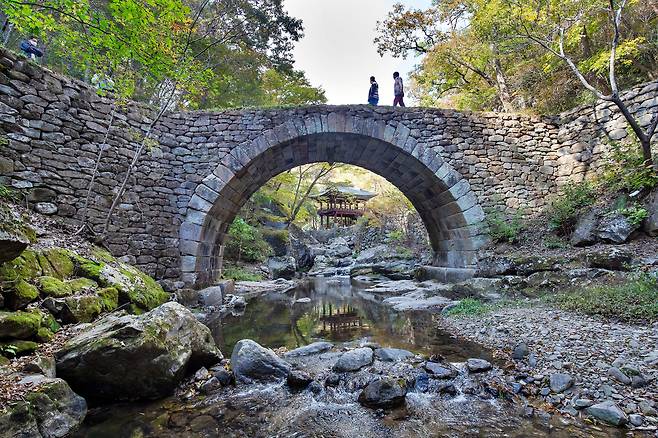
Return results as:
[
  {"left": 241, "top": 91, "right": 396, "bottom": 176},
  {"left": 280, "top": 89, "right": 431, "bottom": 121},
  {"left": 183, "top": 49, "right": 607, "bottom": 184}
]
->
[{"left": 207, "top": 277, "right": 491, "bottom": 362}]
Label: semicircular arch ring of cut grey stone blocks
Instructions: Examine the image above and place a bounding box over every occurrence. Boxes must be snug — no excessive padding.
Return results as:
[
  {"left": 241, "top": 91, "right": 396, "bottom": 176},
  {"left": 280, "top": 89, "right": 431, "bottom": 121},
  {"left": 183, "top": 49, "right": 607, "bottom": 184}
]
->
[{"left": 179, "top": 113, "right": 486, "bottom": 287}]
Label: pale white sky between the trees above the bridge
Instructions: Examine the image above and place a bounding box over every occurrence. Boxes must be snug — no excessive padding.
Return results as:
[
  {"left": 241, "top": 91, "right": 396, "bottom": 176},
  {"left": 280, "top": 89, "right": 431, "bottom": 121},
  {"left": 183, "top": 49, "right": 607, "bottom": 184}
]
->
[{"left": 285, "top": 0, "right": 430, "bottom": 105}]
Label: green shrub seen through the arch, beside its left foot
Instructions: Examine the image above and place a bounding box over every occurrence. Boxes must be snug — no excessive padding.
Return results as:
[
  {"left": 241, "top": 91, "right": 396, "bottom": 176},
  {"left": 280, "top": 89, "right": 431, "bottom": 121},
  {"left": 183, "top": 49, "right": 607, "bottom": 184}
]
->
[{"left": 225, "top": 217, "right": 272, "bottom": 262}]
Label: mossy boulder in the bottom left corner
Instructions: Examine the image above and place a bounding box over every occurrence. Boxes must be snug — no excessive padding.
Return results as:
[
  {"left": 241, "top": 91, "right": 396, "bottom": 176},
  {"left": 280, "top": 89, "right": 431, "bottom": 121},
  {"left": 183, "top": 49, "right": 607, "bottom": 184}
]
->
[{"left": 0, "top": 374, "right": 87, "bottom": 438}]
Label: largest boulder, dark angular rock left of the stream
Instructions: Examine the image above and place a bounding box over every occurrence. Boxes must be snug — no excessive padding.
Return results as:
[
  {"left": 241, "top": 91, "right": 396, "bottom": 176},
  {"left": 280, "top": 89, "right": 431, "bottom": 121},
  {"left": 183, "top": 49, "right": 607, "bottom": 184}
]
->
[{"left": 56, "top": 303, "right": 222, "bottom": 401}]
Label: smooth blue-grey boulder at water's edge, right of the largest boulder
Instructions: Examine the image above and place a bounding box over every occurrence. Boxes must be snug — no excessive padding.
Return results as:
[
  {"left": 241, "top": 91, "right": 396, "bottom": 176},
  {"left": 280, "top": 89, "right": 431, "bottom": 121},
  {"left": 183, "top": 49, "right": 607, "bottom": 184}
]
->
[{"left": 231, "top": 339, "right": 292, "bottom": 382}]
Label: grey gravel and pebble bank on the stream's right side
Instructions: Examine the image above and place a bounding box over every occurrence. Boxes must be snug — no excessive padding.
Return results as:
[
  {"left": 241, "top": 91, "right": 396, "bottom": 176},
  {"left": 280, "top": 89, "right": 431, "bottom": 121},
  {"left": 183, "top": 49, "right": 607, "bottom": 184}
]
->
[{"left": 437, "top": 305, "right": 658, "bottom": 436}]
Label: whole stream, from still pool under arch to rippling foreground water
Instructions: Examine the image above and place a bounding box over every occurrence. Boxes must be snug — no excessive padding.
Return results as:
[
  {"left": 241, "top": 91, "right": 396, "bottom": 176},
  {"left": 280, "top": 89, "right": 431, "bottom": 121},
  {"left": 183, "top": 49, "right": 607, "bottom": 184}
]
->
[{"left": 75, "top": 278, "right": 626, "bottom": 438}]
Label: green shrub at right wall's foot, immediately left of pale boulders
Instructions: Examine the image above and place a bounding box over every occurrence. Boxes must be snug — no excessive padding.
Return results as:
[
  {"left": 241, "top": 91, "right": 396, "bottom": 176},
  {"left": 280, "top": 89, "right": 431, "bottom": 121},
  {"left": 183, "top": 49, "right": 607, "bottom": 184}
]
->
[{"left": 548, "top": 181, "right": 596, "bottom": 236}]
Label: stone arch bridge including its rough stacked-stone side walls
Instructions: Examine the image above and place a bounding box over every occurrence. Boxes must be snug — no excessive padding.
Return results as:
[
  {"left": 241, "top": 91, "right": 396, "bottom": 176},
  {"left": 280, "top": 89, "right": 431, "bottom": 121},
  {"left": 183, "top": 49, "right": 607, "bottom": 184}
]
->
[{"left": 0, "top": 48, "right": 656, "bottom": 289}]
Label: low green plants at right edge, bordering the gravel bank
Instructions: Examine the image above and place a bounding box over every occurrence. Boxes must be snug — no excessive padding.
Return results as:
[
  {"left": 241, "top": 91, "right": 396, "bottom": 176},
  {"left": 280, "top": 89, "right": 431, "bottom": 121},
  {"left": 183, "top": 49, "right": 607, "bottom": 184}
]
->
[{"left": 547, "top": 274, "right": 658, "bottom": 321}]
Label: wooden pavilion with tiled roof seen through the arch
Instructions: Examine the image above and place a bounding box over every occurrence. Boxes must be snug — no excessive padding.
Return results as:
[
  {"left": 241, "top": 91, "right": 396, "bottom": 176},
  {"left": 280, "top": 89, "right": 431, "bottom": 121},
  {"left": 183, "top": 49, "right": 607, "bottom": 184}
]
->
[{"left": 311, "top": 186, "right": 377, "bottom": 228}]
